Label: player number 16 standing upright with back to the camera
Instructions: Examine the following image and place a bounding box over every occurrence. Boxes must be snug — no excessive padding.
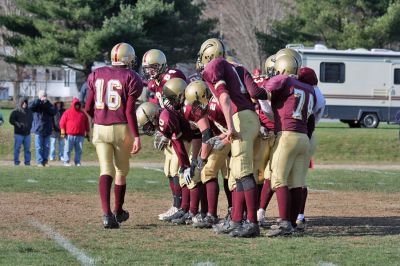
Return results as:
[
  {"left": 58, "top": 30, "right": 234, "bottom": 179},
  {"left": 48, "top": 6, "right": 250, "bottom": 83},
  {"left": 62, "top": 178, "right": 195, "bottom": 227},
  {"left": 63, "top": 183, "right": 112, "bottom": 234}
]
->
[{"left": 85, "top": 43, "right": 143, "bottom": 228}]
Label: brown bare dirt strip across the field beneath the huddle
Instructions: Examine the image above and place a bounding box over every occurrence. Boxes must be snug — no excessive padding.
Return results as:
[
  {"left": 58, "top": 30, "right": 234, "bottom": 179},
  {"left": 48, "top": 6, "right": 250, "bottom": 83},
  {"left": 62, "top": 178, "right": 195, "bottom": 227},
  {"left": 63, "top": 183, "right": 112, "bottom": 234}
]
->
[{"left": 0, "top": 191, "right": 400, "bottom": 241}]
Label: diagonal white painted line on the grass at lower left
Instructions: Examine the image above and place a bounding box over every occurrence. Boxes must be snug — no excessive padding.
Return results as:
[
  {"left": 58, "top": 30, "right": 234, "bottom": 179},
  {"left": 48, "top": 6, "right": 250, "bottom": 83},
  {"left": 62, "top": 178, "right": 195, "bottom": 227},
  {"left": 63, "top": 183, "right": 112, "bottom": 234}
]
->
[{"left": 29, "top": 219, "right": 95, "bottom": 266}]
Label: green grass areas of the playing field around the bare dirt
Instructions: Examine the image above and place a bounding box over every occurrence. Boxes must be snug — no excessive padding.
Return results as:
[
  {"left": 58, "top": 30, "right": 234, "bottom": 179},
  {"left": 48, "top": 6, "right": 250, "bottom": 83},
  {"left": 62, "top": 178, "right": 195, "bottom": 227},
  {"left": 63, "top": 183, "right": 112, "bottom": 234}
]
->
[{"left": 0, "top": 166, "right": 400, "bottom": 265}]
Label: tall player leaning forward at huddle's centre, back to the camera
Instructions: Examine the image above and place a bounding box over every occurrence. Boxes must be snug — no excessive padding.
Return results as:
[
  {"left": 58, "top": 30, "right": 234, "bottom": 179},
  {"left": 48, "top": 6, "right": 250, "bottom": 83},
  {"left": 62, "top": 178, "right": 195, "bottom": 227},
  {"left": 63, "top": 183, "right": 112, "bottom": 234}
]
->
[{"left": 198, "top": 38, "right": 267, "bottom": 237}]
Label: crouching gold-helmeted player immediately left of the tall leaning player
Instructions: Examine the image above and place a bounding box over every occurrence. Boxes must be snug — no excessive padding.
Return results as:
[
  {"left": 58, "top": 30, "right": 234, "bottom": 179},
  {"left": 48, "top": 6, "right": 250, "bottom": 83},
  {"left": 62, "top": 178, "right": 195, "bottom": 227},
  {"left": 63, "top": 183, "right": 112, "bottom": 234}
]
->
[{"left": 184, "top": 80, "right": 231, "bottom": 228}]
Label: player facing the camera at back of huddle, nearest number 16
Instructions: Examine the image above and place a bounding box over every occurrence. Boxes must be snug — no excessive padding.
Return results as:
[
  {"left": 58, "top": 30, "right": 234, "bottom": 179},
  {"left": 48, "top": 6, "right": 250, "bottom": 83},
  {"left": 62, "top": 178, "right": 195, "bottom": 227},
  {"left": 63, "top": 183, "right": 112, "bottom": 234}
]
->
[{"left": 142, "top": 49, "right": 186, "bottom": 220}]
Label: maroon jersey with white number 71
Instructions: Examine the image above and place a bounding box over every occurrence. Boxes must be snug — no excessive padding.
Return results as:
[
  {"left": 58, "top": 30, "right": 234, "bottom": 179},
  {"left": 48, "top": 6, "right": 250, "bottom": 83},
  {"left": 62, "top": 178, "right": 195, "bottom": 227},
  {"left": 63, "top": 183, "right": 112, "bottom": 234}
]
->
[{"left": 264, "top": 75, "right": 315, "bottom": 134}]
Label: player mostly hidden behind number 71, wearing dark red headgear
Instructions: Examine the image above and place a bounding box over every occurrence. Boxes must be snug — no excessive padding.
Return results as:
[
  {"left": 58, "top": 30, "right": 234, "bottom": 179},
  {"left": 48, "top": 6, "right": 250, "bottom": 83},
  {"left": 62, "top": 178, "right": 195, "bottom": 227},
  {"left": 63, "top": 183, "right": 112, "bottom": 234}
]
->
[{"left": 296, "top": 67, "right": 326, "bottom": 230}]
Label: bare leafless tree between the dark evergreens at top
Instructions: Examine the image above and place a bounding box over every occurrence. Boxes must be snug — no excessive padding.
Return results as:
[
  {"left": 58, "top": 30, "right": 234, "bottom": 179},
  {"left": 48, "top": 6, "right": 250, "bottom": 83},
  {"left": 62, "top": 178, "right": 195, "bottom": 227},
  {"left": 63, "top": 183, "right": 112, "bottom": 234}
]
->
[{"left": 203, "top": 0, "right": 291, "bottom": 69}]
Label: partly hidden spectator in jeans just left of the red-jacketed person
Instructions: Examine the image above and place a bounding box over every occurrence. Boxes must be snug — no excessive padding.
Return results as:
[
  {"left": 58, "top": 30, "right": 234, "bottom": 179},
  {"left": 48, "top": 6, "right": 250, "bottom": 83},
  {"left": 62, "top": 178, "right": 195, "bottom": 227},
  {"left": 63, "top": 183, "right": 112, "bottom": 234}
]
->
[{"left": 50, "top": 101, "right": 65, "bottom": 161}]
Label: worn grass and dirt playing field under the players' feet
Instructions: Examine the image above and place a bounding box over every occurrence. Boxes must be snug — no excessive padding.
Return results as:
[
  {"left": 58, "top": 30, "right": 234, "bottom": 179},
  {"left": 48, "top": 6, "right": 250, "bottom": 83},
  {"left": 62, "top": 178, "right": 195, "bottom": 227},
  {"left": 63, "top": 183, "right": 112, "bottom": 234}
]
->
[{"left": 0, "top": 166, "right": 400, "bottom": 265}]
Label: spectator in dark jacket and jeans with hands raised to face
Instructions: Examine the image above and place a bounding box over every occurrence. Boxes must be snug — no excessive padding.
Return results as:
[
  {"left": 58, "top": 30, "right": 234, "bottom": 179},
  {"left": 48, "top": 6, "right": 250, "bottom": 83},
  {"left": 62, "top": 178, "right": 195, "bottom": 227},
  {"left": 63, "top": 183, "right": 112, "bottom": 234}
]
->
[{"left": 29, "top": 90, "right": 56, "bottom": 167}]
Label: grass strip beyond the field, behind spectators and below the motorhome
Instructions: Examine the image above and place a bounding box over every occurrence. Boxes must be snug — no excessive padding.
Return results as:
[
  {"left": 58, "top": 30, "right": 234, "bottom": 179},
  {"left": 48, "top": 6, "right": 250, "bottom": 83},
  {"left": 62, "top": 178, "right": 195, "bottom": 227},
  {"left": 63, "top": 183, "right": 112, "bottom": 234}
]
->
[{"left": 0, "top": 109, "right": 400, "bottom": 164}]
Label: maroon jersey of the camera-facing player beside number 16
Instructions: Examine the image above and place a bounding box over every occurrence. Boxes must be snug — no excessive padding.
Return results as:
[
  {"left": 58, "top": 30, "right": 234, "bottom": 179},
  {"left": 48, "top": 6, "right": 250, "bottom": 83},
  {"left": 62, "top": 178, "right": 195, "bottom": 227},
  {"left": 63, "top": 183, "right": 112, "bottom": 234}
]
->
[{"left": 148, "top": 69, "right": 186, "bottom": 107}]
